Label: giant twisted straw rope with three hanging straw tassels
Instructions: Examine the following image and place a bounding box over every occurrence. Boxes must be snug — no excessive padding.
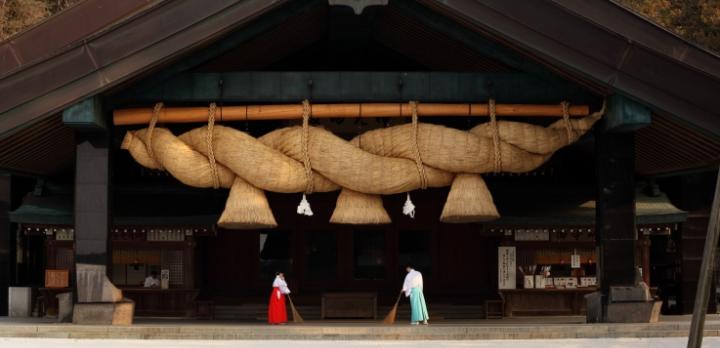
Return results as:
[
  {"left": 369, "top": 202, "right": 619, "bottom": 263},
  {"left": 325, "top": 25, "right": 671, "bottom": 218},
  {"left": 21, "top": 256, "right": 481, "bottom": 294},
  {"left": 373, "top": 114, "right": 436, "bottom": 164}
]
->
[{"left": 122, "top": 101, "right": 604, "bottom": 229}]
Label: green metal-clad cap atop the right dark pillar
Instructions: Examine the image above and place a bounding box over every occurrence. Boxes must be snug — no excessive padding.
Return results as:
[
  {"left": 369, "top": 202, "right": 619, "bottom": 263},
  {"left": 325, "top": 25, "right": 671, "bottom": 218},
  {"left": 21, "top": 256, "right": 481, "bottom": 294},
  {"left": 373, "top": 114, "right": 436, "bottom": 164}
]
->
[{"left": 605, "top": 94, "right": 652, "bottom": 133}]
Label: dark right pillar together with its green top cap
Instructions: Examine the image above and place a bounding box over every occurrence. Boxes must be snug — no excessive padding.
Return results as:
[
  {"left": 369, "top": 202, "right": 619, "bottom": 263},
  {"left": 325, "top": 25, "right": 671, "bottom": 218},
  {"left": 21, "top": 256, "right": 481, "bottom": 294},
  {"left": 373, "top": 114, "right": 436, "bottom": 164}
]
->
[{"left": 595, "top": 95, "right": 651, "bottom": 318}]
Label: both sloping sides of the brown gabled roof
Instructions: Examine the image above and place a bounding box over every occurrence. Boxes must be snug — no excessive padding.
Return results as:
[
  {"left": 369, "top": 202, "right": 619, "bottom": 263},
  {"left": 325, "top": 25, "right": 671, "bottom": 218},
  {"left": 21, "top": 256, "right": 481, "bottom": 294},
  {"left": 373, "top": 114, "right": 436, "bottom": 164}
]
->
[{"left": 0, "top": 0, "right": 720, "bottom": 174}]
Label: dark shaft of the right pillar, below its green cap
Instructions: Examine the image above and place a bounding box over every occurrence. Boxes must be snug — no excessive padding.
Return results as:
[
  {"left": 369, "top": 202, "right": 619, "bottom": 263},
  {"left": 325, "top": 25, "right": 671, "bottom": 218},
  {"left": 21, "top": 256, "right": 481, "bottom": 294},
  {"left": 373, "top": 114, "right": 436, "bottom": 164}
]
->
[{"left": 596, "top": 125, "right": 637, "bottom": 298}]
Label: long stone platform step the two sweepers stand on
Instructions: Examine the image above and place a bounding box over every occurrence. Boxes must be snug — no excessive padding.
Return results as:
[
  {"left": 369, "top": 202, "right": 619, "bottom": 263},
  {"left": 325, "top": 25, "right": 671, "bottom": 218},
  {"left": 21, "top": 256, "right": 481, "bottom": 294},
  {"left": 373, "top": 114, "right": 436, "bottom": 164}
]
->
[{"left": 0, "top": 317, "right": 720, "bottom": 340}]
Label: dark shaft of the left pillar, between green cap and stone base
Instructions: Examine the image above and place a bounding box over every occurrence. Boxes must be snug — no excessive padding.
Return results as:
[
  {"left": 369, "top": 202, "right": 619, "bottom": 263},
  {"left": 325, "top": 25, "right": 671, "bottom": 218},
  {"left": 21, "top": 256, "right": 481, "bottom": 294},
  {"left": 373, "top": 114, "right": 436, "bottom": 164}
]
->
[{"left": 75, "top": 133, "right": 110, "bottom": 265}]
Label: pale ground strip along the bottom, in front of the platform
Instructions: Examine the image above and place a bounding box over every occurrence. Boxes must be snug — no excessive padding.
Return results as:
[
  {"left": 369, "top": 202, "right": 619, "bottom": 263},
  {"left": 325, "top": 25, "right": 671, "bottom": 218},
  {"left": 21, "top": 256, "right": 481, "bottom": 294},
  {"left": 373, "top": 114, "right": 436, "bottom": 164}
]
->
[{"left": 0, "top": 337, "right": 720, "bottom": 348}]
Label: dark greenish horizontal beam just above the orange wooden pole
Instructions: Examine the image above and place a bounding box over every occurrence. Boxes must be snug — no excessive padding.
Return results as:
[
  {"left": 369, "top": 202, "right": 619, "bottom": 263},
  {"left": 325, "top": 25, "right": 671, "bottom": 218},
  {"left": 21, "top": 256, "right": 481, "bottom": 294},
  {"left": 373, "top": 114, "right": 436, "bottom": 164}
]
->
[{"left": 113, "top": 71, "right": 602, "bottom": 108}]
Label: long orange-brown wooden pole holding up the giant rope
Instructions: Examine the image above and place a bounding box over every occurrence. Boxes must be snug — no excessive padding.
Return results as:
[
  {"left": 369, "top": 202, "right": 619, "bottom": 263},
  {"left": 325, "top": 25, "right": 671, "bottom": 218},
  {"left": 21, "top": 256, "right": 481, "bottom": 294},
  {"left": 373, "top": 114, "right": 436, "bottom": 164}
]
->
[{"left": 113, "top": 103, "right": 590, "bottom": 125}]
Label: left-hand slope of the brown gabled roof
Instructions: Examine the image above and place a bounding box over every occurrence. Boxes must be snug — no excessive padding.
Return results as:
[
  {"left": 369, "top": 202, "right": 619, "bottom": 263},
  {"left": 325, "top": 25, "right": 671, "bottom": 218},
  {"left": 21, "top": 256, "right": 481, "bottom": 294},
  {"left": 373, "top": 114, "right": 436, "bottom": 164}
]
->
[{"left": 0, "top": 0, "right": 285, "bottom": 136}]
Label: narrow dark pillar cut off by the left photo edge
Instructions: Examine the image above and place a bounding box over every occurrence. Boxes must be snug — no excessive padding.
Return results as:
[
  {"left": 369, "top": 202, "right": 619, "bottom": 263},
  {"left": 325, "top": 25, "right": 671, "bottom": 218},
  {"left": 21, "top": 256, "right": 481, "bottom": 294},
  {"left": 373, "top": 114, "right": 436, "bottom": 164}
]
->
[{"left": 0, "top": 174, "right": 15, "bottom": 316}]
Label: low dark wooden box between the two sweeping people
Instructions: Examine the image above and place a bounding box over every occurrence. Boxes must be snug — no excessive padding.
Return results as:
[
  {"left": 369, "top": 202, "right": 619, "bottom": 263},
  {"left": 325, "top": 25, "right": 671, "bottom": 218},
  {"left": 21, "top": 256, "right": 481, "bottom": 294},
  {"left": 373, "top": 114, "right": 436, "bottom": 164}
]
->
[{"left": 320, "top": 292, "right": 377, "bottom": 319}]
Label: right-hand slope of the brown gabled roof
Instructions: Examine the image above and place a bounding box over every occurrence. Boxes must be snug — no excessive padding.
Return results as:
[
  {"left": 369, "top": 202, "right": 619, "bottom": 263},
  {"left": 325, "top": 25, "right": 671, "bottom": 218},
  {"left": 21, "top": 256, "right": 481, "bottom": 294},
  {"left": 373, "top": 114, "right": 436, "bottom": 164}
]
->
[{"left": 423, "top": 0, "right": 720, "bottom": 137}]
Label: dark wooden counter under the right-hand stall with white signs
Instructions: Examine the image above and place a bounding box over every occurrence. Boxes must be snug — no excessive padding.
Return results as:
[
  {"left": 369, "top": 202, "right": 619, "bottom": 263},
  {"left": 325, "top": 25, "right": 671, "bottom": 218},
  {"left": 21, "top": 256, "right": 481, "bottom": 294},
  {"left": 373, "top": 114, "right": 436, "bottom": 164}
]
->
[{"left": 499, "top": 287, "right": 597, "bottom": 317}]
